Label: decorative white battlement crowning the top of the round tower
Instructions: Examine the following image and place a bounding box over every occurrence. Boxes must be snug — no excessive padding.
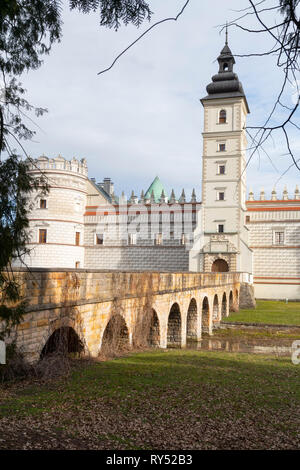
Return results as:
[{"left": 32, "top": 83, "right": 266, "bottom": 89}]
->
[{"left": 27, "top": 155, "right": 88, "bottom": 176}]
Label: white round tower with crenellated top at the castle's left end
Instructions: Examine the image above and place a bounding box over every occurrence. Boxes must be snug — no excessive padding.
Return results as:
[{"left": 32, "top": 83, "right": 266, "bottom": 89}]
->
[{"left": 25, "top": 155, "right": 88, "bottom": 268}]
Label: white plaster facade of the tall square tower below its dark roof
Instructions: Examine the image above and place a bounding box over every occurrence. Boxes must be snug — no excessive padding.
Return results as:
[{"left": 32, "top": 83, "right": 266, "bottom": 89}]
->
[{"left": 190, "top": 97, "right": 252, "bottom": 273}]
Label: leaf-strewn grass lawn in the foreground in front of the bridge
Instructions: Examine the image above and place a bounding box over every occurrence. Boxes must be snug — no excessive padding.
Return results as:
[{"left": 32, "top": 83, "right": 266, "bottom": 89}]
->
[{"left": 0, "top": 350, "right": 300, "bottom": 450}]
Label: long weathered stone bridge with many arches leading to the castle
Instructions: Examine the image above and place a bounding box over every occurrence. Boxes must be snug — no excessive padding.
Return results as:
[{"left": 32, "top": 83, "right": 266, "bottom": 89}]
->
[{"left": 10, "top": 268, "right": 249, "bottom": 361}]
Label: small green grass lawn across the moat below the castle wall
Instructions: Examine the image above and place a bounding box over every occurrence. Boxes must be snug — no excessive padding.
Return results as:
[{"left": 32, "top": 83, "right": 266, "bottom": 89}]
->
[{"left": 222, "top": 300, "right": 300, "bottom": 326}]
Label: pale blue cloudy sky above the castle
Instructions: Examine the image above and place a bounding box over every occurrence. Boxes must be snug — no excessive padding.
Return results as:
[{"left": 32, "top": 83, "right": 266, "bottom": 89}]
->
[{"left": 17, "top": 0, "right": 300, "bottom": 199}]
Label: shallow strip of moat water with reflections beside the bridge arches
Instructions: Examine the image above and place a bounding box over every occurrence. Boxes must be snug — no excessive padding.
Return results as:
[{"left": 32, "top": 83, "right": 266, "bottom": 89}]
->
[{"left": 186, "top": 338, "right": 292, "bottom": 356}]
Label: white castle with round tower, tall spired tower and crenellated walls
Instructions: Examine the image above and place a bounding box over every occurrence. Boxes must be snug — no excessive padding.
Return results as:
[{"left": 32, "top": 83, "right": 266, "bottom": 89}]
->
[{"left": 20, "top": 40, "right": 300, "bottom": 299}]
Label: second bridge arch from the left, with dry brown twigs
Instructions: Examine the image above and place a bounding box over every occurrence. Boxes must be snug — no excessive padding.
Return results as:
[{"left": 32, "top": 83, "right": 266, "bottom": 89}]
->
[{"left": 101, "top": 313, "right": 130, "bottom": 355}]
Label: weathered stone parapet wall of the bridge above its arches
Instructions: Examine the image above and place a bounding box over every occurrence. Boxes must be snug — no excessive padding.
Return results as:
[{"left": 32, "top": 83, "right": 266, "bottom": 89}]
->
[{"left": 15, "top": 268, "right": 242, "bottom": 311}]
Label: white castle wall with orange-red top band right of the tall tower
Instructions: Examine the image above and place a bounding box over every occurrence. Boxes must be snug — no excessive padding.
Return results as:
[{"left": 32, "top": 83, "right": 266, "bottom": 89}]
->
[{"left": 247, "top": 193, "right": 300, "bottom": 300}]
